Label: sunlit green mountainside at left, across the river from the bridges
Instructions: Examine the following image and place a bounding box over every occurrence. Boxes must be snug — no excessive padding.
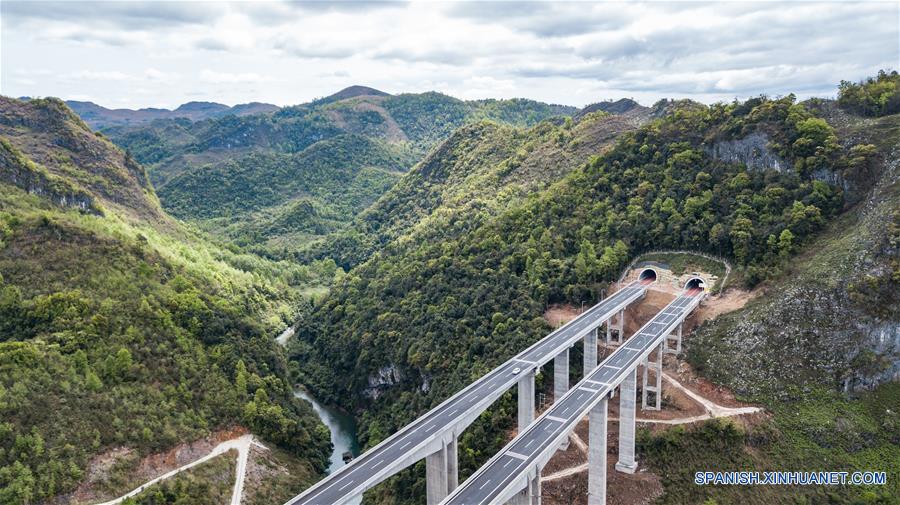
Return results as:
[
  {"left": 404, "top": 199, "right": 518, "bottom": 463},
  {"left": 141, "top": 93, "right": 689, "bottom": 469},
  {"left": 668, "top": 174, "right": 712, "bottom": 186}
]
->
[{"left": 0, "top": 97, "right": 333, "bottom": 504}]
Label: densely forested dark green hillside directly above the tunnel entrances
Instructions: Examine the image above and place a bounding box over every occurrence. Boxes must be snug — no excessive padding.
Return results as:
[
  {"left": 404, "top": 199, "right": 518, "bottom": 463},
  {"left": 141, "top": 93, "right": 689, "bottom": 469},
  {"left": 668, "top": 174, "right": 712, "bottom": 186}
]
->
[{"left": 292, "top": 88, "right": 885, "bottom": 503}]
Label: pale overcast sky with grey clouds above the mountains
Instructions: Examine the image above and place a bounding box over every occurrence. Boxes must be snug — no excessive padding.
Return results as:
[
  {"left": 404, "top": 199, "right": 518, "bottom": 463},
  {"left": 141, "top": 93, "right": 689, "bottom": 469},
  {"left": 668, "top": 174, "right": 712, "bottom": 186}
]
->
[{"left": 0, "top": 0, "right": 900, "bottom": 108}]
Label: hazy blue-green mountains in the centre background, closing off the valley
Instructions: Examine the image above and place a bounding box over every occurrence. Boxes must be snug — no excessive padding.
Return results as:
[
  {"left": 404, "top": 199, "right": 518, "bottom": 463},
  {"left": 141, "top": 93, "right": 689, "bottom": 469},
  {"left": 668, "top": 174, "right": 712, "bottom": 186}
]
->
[{"left": 103, "top": 86, "right": 576, "bottom": 254}]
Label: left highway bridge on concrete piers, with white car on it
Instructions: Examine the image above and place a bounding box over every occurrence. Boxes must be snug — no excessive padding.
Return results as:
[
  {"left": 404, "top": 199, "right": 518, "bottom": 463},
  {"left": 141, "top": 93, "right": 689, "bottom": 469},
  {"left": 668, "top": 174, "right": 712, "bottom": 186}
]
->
[{"left": 286, "top": 278, "right": 656, "bottom": 505}]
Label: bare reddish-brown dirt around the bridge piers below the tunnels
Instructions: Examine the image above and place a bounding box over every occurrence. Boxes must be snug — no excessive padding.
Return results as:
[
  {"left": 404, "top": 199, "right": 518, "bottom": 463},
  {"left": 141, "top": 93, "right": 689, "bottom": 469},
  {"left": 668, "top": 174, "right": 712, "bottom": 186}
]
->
[{"left": 541, "top": 271, "right": 767, "bottom": 505}]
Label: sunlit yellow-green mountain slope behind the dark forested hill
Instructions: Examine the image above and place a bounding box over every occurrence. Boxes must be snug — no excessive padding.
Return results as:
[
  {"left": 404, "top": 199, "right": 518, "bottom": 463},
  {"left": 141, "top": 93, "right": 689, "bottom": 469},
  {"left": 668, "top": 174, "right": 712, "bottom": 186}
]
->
[{"left": 300, "top": 104, "right": 653, "bottom": 269}]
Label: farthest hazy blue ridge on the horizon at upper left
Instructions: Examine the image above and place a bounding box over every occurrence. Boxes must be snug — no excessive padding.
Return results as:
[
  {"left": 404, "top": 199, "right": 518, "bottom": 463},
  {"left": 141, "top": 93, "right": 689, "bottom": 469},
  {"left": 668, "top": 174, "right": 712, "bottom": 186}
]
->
[{"left": 66, "top": 100, "right": 278, "bottom": 130}]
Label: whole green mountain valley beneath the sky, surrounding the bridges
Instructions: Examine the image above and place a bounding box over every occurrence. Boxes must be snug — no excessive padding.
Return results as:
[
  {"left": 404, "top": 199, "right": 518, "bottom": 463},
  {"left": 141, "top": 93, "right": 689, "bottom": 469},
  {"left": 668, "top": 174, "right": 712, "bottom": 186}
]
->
[{"left": 0, "top": 73, "right": 900, "bottom": 505}]
